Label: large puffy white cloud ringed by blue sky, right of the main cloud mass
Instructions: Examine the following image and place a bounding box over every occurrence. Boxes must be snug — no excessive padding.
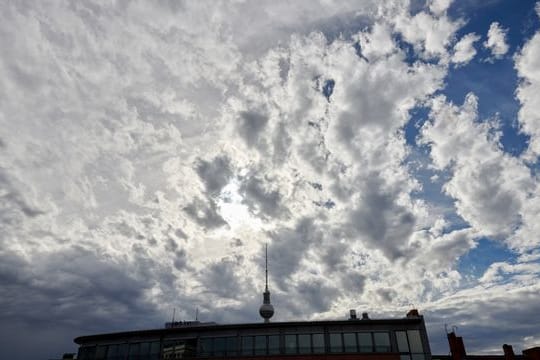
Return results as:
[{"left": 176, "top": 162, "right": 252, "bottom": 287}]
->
[{"left": 421, "top": 94, "right": 536, "bottom": 247}]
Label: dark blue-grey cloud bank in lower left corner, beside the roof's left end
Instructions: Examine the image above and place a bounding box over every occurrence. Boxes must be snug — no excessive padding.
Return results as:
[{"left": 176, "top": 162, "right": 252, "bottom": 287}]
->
[{"left": 0, "top": 247, "right": 165, "bottom": 360}]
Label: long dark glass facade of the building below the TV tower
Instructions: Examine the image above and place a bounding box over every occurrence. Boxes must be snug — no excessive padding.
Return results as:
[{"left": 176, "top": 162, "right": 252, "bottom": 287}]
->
[{"left": 78, "top": 329, "right": 426, "bottom": 360}]
